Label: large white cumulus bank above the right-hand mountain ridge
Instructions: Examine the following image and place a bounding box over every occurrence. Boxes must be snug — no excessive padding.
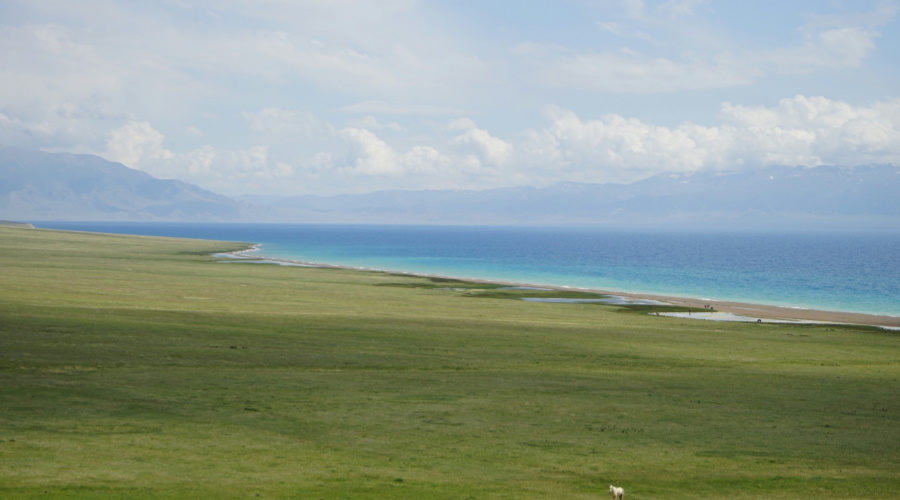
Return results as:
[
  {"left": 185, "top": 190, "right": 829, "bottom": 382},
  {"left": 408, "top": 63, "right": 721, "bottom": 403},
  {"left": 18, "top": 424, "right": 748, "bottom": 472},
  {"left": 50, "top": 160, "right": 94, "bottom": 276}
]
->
[{"left": 518, "top": 96, "right": 900, "bottom": 182}]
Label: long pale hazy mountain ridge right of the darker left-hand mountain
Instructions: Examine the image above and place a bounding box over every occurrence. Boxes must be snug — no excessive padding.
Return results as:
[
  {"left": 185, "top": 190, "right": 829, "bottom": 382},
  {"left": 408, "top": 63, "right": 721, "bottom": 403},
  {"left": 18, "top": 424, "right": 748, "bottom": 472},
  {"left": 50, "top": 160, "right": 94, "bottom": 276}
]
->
[{"left": 258, "top": 165, "right": 900, "bottom": 227}]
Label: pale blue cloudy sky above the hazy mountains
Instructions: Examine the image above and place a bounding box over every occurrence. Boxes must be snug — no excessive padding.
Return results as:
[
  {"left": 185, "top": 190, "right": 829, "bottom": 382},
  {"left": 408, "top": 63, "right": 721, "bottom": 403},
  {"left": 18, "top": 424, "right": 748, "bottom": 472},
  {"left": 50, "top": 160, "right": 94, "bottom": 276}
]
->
[{"left": 0, "top": 0, "right": 900, "bottom": 196}]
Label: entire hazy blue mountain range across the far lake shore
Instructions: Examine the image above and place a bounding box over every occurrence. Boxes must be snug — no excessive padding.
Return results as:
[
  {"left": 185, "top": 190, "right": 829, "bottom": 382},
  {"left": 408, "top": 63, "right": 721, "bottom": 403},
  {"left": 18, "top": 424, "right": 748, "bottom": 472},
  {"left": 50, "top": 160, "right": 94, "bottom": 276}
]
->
[{"left": 0, "top": 148, "right": 900, "bottom": 231}]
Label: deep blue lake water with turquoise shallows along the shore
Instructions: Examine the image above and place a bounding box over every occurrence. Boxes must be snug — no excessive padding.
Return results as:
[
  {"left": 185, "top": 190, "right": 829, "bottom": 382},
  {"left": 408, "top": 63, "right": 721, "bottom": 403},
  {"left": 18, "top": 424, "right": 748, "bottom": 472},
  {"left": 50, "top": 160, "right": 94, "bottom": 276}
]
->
[{"left": 29, "top": 222, "right": 900, "bottom": 316}]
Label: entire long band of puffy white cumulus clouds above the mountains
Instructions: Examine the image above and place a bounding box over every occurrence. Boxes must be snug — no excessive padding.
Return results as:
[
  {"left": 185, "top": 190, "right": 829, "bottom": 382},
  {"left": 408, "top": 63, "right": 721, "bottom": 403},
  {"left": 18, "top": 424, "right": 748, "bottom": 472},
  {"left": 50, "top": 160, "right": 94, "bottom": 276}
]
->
[{"left": 54, "top": 95, "right": 900, "bottom": 194}]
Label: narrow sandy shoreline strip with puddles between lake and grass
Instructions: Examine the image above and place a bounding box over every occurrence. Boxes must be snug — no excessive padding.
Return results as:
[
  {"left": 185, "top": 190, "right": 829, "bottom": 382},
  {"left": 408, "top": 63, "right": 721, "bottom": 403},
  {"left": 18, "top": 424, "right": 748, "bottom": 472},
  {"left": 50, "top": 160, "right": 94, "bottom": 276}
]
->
[{"left": 217, "top": 248, "right": 900, "bottom": 330}]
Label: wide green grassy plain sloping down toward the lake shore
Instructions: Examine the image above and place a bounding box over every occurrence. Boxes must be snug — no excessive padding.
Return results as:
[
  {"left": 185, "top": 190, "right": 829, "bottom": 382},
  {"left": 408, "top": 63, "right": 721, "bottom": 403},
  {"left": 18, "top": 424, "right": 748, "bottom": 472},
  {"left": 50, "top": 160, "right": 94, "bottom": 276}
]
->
[{"left": 0, "top": 228, "right": 900, "bottom": 500}]
